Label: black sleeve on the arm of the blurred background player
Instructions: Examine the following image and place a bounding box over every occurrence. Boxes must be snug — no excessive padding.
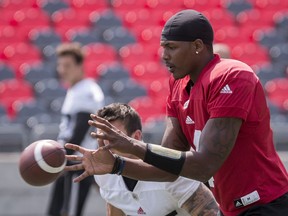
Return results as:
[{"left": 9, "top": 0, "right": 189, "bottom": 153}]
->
[{"left": 66, "top": 112, "right": 91, "bottom": 155}]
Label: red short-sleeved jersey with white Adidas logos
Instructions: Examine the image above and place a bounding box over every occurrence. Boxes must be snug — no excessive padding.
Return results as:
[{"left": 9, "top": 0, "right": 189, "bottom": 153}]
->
[{"left": 167, "top": 55, "right": 288, "bottom": 216}]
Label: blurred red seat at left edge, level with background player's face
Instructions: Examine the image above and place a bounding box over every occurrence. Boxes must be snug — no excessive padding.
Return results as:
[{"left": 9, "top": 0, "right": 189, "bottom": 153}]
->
[{"left": 2, "top": 43, "right": 41, "bottom": 78}]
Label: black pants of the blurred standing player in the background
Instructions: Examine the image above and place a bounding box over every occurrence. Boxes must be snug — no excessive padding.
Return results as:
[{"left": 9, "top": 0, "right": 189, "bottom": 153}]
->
[{"left": 48, "top": 171, "right": 94, "bottom": 216}]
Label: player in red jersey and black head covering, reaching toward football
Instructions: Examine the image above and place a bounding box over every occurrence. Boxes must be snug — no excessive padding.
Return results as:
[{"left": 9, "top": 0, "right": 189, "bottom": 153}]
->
[{"left": 67, "top": 10, "right": 288, "bottom": 216}]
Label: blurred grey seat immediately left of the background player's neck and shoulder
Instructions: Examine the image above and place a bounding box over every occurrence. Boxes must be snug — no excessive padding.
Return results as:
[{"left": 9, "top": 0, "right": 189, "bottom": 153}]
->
[{"left": 34, "top": 79, "right": 66, "bottom": 102}]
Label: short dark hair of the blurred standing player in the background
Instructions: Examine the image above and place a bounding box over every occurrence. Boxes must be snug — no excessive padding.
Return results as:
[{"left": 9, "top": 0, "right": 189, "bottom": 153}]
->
[{"left": 56, "top": 43, "right": 84, "bottom": 65}]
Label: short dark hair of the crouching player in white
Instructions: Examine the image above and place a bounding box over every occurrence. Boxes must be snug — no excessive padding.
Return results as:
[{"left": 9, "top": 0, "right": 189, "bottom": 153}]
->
[{"left": 97, "top": 103, "right": 142, "bottom": 136}]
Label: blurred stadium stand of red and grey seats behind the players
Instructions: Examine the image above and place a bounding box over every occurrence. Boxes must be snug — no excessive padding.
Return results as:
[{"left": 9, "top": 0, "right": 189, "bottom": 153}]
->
[{"left": 0, "top": 0, "right": 288, "bottom": 151}]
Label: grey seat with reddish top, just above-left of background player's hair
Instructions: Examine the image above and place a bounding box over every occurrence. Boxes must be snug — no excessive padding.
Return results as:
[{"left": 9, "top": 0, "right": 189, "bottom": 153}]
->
[{"left": 29, "top": 28, "right": 61, "bottom": 49}]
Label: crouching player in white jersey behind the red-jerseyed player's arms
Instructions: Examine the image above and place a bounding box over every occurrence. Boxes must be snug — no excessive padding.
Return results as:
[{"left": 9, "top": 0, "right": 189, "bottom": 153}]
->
[{"left": 95, "top": 103, "right": 218, "bottom": 216}]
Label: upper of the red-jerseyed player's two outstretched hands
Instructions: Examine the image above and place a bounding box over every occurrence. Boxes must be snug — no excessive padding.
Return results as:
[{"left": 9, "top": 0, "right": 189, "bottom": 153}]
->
[{"left": 88, "top": 114, "right": 133, "bottom": 154}]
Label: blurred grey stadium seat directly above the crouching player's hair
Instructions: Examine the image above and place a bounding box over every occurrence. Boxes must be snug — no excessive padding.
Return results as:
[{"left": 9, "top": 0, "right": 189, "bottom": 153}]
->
[{"left": 111, "top": 79, "right": 147, "bottom": 103}]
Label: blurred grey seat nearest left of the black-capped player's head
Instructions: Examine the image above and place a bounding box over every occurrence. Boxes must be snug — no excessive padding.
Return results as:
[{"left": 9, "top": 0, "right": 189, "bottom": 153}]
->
[{"left": 103, "top": 27, "right": 136, "bottom": 49}]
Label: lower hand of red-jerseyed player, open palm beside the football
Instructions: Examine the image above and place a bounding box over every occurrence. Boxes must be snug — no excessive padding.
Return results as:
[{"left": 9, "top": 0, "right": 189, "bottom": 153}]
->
[{"left": 65, "top": 140, "right": 115, "bottom": 182}]
